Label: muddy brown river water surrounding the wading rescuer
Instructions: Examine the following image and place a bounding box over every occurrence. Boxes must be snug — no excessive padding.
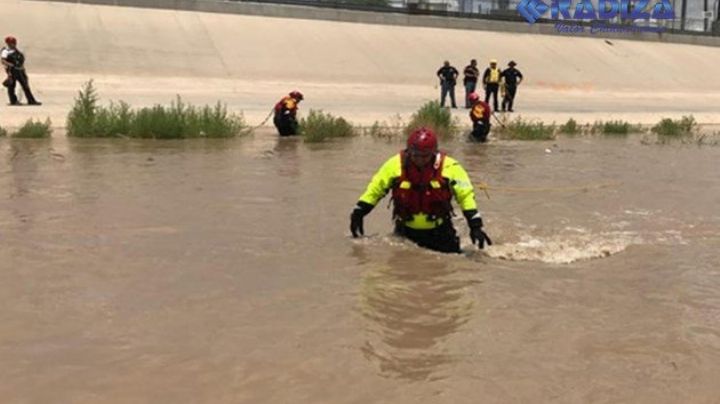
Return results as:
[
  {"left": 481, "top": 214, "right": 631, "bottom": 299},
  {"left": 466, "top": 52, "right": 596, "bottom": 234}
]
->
[{"left": 0, "top": 132, "right": 720, "bottom": 403}]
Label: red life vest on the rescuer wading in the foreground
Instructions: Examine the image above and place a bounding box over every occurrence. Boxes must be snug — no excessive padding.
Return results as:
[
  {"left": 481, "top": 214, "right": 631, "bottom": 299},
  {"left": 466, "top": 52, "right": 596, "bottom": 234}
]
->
[{"left": 392, "top": 151, "right": 452, "bottom": 220}]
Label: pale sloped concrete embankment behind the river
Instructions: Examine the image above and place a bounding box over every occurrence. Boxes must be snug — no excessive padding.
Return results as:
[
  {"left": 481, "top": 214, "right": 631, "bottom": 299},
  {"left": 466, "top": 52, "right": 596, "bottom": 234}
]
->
[{"left": 0, "top": 0, "right": 720, "bottom": 126}]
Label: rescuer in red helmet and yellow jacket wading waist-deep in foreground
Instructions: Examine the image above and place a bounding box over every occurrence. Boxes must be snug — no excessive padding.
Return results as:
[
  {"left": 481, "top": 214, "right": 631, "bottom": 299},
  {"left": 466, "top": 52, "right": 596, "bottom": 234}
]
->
[{"left": 350, "top": 128, "right": 492, "bottom": 253}]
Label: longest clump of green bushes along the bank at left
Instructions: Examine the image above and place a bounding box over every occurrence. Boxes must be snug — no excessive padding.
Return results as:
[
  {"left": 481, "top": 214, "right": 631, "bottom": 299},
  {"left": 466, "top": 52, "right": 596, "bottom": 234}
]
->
[{"left": 67, "top": 80, "right": 247, "bottom": 139}]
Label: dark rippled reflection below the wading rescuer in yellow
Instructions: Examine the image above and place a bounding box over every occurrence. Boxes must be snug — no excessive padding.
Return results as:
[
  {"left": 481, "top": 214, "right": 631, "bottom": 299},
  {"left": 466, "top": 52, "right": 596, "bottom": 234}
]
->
[{"left": 354, "top": 249, "right": 477, "bottom": 381}]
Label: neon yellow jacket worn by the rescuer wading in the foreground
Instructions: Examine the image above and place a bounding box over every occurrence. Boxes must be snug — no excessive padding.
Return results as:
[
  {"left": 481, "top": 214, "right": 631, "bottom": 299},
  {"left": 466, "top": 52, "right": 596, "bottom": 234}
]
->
[{"left": 360, "top": 153, "right": 477, "bottom": 230}]
